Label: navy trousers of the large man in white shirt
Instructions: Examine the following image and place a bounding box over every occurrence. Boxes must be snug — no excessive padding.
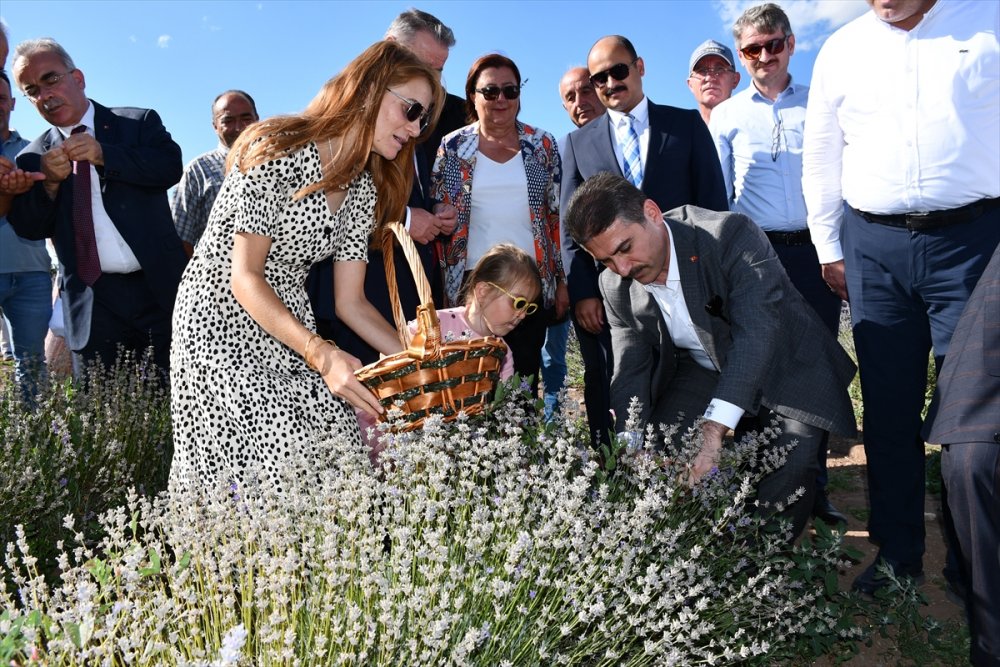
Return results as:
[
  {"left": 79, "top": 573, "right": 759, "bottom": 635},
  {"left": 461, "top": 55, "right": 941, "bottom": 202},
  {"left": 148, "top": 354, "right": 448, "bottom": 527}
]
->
[{"left": 841, "top": 207, "right": 1000, "bottom": 568}]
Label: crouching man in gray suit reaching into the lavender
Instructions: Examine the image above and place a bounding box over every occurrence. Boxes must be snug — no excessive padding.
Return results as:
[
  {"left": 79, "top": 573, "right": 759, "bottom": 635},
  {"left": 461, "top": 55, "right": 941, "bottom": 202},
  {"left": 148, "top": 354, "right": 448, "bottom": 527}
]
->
[{"left": 563, "top": 173, "right": 856, "bottom": 536}]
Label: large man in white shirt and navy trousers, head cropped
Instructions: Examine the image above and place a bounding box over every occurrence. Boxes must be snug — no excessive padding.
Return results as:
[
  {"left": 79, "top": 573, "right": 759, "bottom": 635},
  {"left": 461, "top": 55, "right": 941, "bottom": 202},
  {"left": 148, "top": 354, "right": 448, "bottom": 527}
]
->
[{"left": 802, "top": 0, "right": 1000, "bottom": 593}]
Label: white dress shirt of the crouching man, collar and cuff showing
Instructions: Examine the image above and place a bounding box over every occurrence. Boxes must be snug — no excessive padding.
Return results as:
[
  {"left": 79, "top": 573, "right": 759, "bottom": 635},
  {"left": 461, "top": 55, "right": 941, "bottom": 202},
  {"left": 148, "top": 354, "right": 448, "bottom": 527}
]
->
[{"left": 644, "top": 222, "right": 743, "bottom": 428}]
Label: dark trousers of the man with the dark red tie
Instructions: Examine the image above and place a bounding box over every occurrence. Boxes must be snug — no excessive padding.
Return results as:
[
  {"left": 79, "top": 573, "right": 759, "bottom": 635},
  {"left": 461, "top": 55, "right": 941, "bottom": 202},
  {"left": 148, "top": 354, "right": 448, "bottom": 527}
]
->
[{"left": 73, "top": 271, "right": 172, "bottom": 378}]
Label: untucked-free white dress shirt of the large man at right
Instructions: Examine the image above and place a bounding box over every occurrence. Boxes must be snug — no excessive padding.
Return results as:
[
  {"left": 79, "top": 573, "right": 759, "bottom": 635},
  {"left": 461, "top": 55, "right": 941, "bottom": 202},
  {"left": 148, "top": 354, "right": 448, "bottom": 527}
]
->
[{"left": 802, "top": 0, "right": 1000, "bottom": 264}]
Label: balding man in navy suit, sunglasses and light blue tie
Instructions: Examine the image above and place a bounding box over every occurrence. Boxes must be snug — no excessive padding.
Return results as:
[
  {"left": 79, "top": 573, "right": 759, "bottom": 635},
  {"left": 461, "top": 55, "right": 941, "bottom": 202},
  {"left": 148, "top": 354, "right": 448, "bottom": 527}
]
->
[{"left": 560, "top": 35, "right": 729, "bottom": 442}]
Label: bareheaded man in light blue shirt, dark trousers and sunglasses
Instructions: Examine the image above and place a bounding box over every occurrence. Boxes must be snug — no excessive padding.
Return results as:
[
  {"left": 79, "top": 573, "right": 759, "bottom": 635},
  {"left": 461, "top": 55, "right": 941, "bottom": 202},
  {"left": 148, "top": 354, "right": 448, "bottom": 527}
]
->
[{"left": 709, "top": 3, "right": 847, "bottom": 524}]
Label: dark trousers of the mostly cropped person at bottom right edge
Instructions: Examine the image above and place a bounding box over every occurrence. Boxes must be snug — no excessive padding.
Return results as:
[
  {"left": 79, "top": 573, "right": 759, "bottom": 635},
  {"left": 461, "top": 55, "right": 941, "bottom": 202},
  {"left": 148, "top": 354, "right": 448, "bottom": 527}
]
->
[{"left": 941, "top": 442, "right": 1000, "bottom": 666}]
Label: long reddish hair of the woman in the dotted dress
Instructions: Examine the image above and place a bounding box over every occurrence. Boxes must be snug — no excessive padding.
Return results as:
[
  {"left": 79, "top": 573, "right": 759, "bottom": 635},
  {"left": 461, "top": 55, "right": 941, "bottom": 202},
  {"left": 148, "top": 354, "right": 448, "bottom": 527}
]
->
[{"left": 228, "top": 41, "right": 445, "bottom": 226}]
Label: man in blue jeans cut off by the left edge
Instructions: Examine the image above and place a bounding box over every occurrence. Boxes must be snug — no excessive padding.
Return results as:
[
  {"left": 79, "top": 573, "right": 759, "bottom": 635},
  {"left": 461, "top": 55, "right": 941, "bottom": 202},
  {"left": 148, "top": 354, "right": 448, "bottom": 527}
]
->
[{"left": 0, "top": 72, "right": 52, "bottom": 399}]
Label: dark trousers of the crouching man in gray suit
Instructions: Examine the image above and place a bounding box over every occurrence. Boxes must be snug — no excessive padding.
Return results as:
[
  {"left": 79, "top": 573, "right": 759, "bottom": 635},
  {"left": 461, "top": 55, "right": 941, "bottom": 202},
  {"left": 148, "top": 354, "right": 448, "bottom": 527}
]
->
[{"left": 654, "top": 350, "right": 827, "bottom": 539}]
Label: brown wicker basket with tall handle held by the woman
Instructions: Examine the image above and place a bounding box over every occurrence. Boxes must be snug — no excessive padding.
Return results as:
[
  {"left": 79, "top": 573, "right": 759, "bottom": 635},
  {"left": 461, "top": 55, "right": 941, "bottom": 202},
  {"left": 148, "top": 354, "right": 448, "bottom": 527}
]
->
[{"left": 355, "top": 222, "right": 507, "bottom": 431}]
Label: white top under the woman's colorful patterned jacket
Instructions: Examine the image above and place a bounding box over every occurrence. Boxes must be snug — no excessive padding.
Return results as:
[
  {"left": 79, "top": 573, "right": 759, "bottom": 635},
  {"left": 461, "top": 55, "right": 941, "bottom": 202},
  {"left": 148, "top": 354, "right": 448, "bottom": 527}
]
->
[{"left": 466, "top": 151, "right": 535, "bottom": 269}]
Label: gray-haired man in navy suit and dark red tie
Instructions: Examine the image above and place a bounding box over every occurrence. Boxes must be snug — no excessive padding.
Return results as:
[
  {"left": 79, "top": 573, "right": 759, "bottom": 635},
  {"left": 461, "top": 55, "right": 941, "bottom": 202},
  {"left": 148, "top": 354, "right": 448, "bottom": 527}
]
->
[{"left": 8, "top": 38, "right": 186, "bottom": 369}]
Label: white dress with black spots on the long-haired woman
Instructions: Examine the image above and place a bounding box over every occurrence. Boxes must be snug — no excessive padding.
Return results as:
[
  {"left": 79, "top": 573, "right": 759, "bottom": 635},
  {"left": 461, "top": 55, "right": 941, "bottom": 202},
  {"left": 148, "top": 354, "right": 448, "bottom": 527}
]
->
[{"left": 170, "top": 144, "right": 375, "bottom": 488}]
